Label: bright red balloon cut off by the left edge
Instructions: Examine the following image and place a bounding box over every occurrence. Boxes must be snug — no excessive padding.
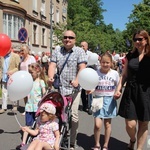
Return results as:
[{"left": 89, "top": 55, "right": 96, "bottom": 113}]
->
[{"left": 0, "top": 34, "right": 11, "bottom": 56}]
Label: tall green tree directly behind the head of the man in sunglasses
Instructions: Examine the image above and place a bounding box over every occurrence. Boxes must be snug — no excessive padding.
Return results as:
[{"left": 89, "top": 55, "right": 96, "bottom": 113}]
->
[{"left": 67, "top": 0, "right": 104, "bottom": 50}]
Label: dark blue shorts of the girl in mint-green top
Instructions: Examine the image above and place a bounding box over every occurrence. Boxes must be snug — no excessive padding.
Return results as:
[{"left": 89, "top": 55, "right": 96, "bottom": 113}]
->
[{"left": 25, "top": 112, "right": 35, "bottom": 126}]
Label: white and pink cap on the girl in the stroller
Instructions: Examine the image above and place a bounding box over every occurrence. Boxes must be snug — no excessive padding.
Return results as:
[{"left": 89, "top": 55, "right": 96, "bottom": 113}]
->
[{"left": 40, "top": 103, "right": 56, "bottom": 114}]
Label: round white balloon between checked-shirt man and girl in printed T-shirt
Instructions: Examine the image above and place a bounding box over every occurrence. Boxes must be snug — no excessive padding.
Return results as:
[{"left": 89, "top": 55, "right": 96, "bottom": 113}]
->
[{"left": 78, "top": 68, "right": 99, "bottom": 90}]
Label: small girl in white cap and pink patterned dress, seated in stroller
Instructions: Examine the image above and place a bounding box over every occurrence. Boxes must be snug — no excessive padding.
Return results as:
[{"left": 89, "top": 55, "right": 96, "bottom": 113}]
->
[{"left": 22, "top": 103, "right": 60, "bottom": 150}]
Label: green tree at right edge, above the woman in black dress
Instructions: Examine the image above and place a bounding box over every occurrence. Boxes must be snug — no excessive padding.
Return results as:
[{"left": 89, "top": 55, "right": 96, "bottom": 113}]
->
[{"left": 122, "top": 0, "right": 150, "bottom": 51}]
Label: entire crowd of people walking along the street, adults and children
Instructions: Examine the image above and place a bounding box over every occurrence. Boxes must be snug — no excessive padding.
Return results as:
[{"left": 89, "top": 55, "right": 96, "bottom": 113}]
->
[{"left": 0, "top": 30, "right": 150, "bottom": 150}]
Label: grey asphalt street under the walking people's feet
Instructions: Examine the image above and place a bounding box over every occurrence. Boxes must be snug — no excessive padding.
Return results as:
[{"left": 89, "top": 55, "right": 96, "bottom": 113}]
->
[{"left": 0, "top": 96, "right": 150, "bottom": 150}]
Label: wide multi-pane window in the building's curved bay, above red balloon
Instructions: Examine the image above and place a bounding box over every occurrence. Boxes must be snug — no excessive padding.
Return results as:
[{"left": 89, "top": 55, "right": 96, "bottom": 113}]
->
[{"left": 3, "top": 13, "right": 25, "bottom": 40}]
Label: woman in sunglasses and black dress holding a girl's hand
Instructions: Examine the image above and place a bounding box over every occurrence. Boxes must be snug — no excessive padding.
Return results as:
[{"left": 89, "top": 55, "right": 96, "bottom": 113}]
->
[{"left": 114, "top": 30, "right": 150, "bottom": 150}]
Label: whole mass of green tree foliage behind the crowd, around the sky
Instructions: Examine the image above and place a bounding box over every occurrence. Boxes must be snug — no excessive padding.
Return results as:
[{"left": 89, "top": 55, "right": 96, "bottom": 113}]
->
[{"left": 54, "top": 0, "right": 150, "bottom": 53}]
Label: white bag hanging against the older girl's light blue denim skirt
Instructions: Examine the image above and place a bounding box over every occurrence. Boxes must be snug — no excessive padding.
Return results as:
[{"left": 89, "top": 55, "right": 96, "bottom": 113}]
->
[{"left": 91, "top": 97, "right": 103, "bottom": 112}]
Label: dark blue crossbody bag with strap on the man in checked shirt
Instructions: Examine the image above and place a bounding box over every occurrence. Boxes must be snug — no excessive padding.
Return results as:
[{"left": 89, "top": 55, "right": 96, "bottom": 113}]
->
[{"left": 53, "top": 52, "right": 71, "bottom": 89}]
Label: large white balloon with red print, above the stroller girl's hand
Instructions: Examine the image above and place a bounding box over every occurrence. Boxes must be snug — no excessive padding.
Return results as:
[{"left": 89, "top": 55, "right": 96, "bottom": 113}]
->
[{"left": 7, "top": 70, "right": 33, "bottom": 101}]
